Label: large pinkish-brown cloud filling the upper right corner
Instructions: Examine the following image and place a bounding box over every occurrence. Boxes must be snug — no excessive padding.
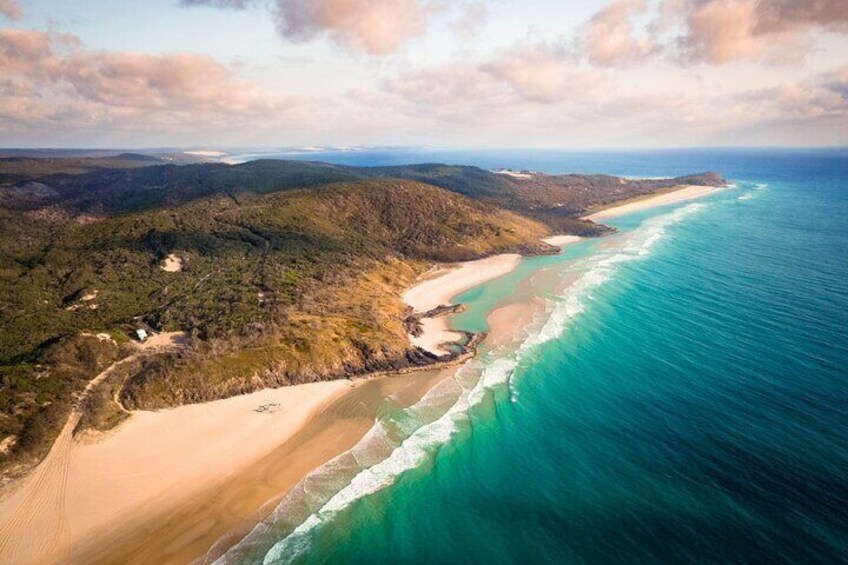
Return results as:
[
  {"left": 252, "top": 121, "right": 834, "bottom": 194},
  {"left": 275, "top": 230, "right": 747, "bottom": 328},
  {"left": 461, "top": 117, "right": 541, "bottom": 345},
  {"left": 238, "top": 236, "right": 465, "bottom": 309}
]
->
[{"left": 665, "top": 0, "right": 848, "bottom": 65}]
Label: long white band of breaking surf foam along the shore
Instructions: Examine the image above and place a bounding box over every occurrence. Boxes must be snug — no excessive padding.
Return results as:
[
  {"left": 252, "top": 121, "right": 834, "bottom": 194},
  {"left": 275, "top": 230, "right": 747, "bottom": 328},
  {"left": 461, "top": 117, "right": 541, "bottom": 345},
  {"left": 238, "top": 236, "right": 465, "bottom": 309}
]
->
[{"left": 218, "top": 203, "right": 706, "bottom": 564}]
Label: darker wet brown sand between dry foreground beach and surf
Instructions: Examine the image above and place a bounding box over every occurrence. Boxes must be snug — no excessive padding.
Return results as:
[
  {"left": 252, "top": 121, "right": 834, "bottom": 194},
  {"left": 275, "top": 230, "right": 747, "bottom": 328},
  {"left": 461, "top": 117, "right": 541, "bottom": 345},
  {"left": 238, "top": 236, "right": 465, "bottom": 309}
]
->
[{"left": 50, "top": 369, "right": 451, "bottom": 564}]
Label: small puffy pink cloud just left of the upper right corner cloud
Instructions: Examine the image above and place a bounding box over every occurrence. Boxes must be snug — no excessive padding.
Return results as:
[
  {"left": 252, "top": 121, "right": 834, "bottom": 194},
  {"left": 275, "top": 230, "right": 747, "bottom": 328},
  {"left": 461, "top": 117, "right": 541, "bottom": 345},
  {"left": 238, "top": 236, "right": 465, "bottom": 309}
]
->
[{"left": 580, "top": 0, "right": 656, "bottom": 67}]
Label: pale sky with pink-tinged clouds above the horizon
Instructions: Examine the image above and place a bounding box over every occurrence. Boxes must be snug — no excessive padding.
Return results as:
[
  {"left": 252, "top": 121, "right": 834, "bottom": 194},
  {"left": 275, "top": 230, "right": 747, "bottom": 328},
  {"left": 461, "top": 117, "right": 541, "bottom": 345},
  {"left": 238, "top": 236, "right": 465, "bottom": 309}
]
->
[{"left": 0, "top": 0, "right": 848, "bottom": 149}]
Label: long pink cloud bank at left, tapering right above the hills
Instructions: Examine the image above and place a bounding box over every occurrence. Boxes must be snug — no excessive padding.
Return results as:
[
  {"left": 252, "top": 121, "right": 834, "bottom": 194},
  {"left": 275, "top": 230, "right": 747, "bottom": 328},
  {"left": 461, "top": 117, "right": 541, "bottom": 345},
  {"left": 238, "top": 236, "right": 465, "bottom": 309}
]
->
[{"left": 0, "top": 29, "right": 303, "bottom": 140}]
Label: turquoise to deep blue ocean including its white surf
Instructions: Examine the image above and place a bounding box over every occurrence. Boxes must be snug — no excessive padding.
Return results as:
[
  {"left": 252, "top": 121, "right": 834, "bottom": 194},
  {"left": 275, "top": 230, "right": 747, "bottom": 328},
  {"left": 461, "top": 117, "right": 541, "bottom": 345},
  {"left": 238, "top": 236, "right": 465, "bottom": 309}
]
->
[{"left": 222, "top": 149, "right": 848, "bottom": 564}]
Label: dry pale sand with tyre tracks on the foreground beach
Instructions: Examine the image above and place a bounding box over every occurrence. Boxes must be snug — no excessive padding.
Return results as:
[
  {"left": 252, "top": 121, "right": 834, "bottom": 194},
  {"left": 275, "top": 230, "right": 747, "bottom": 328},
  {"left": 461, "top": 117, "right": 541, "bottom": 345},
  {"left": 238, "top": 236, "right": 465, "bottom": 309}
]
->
[{"left": 0, "top": 381, "right": 353, "bottom": 564}]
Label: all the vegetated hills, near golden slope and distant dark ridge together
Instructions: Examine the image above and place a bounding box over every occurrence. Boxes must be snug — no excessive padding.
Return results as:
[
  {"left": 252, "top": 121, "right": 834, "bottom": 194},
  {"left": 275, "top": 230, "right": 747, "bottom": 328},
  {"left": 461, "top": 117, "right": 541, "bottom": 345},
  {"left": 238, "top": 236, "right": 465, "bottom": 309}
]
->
[{"left": 0, "top": 155, "right": 718, "bottom": 473}]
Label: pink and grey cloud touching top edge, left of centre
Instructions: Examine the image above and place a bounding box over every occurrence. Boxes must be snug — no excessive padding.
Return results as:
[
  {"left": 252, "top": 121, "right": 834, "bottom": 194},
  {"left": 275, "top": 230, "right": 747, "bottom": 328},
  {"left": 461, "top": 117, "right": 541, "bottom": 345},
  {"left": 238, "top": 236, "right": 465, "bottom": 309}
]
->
[{"left": 275, "top": 0, "right": 437, "bottom": 55}]
